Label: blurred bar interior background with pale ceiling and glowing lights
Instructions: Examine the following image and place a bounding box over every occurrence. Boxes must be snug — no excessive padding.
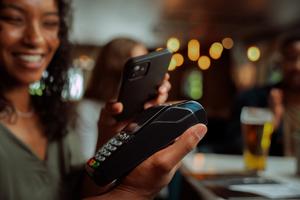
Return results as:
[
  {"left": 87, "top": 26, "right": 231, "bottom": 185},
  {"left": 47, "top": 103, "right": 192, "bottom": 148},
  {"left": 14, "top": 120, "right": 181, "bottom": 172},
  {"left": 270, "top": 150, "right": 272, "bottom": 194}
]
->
[{"left": 62, "top": 0, "right": 300, "bottom": 148}]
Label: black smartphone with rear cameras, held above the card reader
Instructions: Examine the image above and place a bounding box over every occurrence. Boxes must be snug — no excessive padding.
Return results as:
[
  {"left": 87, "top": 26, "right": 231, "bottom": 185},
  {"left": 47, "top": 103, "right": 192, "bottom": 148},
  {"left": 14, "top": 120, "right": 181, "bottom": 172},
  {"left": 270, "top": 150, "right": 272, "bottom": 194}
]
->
[{"left": 116, "top": 49, "right": 172, "bottom": 120}]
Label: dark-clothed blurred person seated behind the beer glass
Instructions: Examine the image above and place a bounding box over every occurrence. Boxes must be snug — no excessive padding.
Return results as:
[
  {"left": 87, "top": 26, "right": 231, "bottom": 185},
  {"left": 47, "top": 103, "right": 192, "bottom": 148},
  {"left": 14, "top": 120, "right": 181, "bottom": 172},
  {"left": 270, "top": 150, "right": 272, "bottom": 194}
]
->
[{"left": 228, "top": 31, "right": 300, "bottom": 156}]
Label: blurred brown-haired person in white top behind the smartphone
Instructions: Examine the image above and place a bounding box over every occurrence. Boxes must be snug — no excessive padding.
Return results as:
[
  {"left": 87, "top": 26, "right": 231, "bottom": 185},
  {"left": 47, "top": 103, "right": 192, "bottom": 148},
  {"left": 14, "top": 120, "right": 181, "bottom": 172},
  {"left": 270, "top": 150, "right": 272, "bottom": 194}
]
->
[{"left": 75, "top": 37, "right": 171, "bottom": 159}]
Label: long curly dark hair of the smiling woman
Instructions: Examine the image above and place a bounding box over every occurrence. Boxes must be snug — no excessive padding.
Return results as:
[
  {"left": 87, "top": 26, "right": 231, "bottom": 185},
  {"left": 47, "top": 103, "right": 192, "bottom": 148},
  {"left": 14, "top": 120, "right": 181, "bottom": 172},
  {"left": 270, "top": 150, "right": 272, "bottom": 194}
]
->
[{"left": 0, "top": 0, "right": 73, "bottom": 140}]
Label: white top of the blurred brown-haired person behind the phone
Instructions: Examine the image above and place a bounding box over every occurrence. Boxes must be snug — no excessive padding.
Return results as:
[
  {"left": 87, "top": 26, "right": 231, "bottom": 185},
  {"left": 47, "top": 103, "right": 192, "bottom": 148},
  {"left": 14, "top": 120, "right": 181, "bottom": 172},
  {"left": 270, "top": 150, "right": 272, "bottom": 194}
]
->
[{"left": 74, "top": 99, "right": 104, "bottom": 160}]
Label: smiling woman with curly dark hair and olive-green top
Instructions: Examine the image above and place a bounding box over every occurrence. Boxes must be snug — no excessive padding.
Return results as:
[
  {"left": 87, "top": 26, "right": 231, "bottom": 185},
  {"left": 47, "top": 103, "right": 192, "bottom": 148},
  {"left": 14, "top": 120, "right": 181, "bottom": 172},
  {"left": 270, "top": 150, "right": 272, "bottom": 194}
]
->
[{"left": 0, "top": 0, "right": 77, "bottom": 199}]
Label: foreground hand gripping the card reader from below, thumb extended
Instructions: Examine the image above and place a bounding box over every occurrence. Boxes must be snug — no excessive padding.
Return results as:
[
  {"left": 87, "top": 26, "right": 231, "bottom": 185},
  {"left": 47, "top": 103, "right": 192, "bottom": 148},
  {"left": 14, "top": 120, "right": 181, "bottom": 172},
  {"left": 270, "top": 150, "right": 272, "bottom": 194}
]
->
[{"left": 89, "top": 124, "right": 207, "bottom": 200}]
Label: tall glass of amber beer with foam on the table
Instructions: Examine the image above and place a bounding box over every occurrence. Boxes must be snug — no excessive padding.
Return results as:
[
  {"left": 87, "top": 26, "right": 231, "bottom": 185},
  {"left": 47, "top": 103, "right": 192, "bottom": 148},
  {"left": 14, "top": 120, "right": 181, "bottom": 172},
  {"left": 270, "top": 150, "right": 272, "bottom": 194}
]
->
[{"left": 241, "top": 107, "right": 273, "bottom": 171}]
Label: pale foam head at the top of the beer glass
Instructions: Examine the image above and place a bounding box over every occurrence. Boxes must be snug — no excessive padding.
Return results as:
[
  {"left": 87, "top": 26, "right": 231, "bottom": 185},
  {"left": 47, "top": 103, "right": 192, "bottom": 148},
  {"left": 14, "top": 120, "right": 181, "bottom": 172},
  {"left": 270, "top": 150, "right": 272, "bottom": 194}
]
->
[{"left": 241, "top": 106, "right": 273, "bottom": 125}]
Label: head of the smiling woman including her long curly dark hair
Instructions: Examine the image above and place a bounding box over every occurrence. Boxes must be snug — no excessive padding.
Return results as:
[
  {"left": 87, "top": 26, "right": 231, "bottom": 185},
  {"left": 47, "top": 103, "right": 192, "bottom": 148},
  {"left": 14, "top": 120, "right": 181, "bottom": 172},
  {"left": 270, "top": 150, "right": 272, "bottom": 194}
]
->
[{"left": 0, "top": 0, "right": 69, "bottom": 142}]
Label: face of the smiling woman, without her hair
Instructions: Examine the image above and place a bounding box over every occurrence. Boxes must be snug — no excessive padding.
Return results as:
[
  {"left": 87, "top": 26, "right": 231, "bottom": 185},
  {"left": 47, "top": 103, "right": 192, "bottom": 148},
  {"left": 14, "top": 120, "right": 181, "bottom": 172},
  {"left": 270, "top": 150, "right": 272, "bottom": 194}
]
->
[{"left": 1, "top": 1, "right": 59, "bottom": 84}]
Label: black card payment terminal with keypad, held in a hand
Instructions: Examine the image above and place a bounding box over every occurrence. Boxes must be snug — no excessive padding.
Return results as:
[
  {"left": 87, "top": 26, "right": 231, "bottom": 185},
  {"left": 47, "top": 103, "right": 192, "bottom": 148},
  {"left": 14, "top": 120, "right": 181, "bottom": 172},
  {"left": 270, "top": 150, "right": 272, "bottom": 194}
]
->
[{"left": 86, "top": 101, "right": 207, "bottom": 185}]
